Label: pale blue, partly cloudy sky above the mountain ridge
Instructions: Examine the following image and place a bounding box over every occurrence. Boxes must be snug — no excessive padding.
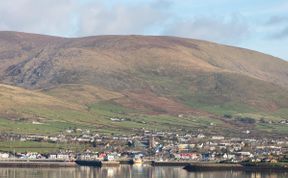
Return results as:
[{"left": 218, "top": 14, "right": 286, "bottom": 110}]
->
[{"left": 0, "top": 0, "right": 288, "bottom": 60}]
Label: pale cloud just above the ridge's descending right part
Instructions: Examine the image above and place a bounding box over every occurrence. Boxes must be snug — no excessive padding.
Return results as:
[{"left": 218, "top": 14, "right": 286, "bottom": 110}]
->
[{"left": 164, "top": 16, "right": 249, "bottom": 43}]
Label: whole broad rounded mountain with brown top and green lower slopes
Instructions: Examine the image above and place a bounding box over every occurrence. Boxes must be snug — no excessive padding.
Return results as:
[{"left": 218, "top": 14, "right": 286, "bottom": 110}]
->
[{"left": 0, "top": 32, "right": 288, "bottom": 134}]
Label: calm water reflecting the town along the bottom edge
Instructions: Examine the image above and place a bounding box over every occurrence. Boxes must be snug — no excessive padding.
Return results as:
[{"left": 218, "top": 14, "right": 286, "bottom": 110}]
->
[{"left": 0, "top": 165, "right": 288, "bottom": 178}]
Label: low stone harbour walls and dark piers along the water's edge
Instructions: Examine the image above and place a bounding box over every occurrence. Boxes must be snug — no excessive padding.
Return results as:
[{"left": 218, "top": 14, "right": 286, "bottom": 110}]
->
[{"left": 0, "top": 160, "right": 288, "bottom": 172}]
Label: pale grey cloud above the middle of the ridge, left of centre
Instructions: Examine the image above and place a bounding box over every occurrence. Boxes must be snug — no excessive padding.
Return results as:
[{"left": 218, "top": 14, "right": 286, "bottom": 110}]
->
[{"left": 77, "top": 3, "right": 168, "bottom": 35}]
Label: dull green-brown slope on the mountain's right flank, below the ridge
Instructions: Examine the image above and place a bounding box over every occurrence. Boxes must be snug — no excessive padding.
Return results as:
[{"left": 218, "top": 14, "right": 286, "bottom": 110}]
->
[{"left": 134, "top": 69, "right": 288, "bottom": 118}]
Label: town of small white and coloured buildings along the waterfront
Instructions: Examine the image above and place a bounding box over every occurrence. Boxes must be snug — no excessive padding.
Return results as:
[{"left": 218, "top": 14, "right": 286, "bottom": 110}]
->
[{"left": 0, "top": 128, "right": 288, "bottom": 163}]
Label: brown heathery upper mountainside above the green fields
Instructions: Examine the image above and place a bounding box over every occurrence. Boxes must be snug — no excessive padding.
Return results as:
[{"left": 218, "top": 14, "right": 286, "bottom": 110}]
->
[{"left": 0, "top": 32, "right": 288, "bottom": 116}]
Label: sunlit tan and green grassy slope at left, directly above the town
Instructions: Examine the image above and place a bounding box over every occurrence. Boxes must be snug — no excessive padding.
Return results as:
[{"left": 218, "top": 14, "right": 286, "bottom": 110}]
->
[{"left": 0, "top": 82, "right": 228, "bottom": 135}]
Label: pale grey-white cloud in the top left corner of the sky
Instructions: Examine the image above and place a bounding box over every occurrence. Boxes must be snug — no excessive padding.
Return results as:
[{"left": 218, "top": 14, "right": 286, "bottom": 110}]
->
[{"left": 0, "top": 0, "right": 76, "bottom": 34}]
